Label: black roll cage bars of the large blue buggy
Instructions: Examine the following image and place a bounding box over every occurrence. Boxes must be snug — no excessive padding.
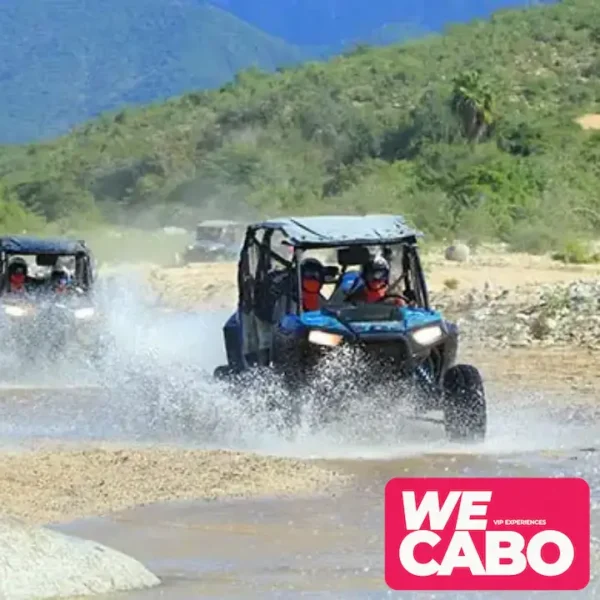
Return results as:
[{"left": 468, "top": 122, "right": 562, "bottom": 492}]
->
[{"left": 238, "top": 222, "right": 430, "bottom": 314}]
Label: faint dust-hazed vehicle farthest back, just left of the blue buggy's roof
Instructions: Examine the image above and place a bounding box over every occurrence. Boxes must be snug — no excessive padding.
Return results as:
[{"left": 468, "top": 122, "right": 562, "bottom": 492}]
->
[{"left": 183, "top": 221, "right": 246, "bottom": 263}]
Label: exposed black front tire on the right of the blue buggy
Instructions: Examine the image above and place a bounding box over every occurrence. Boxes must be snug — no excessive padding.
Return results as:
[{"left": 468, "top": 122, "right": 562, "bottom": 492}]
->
[{"left": 443, "top": 365, "right": 487, "bottom": 442}]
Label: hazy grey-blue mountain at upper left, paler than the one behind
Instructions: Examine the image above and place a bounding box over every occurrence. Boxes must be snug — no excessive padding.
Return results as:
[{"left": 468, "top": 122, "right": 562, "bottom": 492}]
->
[{"left": 0, "top": 0, "right": 305, "bottom": 142}]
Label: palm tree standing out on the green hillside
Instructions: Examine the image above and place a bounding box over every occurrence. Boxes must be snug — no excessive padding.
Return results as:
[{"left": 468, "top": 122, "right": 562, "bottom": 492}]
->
[{"left": 451, "top": 70, "right": 494, "bottom": 142}]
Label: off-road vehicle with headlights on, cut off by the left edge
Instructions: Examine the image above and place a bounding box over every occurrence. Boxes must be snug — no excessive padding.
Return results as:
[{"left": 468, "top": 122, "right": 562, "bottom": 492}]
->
[{"left": 0, "top": 236, "right": 111, "bottom": 361}]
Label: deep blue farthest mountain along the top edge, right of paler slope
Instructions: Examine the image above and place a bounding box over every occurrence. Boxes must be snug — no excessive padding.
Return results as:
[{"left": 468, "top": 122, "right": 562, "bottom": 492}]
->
[{"left": 212, "top": 0, "right": 553, "bottom": 51}]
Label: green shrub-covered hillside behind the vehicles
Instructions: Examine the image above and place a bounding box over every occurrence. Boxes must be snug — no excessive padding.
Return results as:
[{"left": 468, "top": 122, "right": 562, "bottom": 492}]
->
[{"left": 0, "top": 0, "right": 600, "bottom": 253}]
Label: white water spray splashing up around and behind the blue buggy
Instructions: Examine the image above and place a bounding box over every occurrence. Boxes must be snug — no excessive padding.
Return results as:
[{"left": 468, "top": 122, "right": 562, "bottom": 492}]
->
[{"left": 0, "top": 272, "right": 597, "bottom": 458}]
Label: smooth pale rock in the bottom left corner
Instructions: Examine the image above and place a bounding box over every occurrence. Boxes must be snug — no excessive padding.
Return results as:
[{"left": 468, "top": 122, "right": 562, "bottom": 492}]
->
[{"left": 0, "top": 517, "right": 160, "bottom": 600}]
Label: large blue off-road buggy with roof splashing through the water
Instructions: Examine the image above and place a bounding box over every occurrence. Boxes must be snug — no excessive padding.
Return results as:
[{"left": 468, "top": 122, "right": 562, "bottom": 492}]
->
[{"left": 215, "top": 215, "right": 487, "bottom": 441}]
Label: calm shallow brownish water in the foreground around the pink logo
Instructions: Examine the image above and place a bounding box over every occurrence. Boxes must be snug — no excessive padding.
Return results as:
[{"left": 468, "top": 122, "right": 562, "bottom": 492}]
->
[{"left": 55, "top": 440, "right": 599, "bottom": 600}]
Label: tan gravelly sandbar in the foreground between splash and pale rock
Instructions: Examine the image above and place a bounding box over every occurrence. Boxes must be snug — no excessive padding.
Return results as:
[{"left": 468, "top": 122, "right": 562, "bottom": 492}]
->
[{"left": 0, "top": 445, "right": 348, "bottom": 524}]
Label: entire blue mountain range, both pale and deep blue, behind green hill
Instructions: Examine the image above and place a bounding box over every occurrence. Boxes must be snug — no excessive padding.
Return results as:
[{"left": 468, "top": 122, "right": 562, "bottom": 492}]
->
[{"left": 0, "top": 0, "right": 556, "bottom": 143}]
